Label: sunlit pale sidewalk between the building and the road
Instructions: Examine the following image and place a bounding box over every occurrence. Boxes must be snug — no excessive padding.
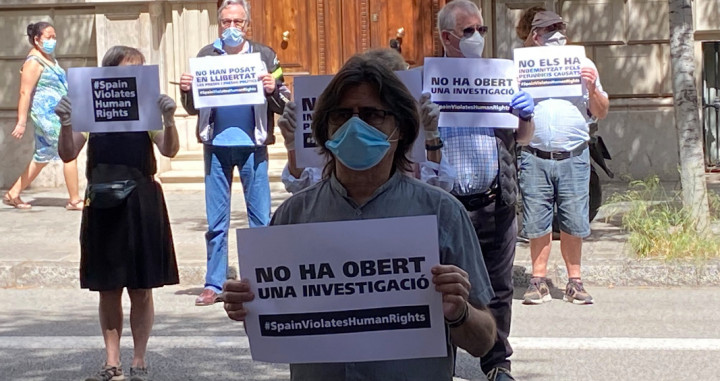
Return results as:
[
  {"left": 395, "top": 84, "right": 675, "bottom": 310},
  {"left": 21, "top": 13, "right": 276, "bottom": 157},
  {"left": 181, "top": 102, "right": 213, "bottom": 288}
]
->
[{"left": 0, "top": 183, "right": 720, "bottom": 288}]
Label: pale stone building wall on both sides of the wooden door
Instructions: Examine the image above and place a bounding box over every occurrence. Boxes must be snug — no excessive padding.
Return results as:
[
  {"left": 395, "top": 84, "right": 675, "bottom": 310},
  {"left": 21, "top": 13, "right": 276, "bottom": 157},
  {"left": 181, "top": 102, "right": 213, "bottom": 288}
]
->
[{"left": 0, "top": 0, "right": 720, "bottom": 188}]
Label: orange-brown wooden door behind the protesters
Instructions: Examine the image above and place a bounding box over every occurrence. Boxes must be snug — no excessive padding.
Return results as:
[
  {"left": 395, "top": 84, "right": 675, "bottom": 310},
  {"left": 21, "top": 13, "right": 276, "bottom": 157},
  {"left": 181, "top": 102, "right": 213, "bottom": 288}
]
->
[{"left": 250, "top": 0, "right": 447, "bottom": 84}]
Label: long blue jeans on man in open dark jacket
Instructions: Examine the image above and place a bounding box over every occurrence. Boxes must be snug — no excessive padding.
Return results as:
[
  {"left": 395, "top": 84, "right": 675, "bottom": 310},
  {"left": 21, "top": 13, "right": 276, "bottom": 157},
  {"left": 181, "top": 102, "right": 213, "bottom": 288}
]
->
[{"left": 203, "top": 144, "right": 270, "bottom": 292}]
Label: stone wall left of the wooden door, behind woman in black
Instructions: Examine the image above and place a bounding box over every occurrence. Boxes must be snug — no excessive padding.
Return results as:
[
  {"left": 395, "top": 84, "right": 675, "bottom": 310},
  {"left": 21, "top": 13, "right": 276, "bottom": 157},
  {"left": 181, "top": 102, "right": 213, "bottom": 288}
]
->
[{"left": 0, "top": 0, "right": 217, "bottom": 188}]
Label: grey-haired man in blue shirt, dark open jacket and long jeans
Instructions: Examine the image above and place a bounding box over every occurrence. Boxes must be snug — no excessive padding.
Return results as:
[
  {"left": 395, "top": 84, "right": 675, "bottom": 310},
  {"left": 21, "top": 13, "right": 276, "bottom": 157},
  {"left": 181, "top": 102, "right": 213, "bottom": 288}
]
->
[{"left": 180, "top": 0, "right": 289, "bottom": 306}]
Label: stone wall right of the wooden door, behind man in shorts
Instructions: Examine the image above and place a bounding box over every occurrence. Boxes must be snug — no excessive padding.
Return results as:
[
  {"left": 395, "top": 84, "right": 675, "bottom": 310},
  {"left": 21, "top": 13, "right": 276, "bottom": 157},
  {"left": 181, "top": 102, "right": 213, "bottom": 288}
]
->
[{"left": 492, "top": 0, "right": 720, "bottom": 180}]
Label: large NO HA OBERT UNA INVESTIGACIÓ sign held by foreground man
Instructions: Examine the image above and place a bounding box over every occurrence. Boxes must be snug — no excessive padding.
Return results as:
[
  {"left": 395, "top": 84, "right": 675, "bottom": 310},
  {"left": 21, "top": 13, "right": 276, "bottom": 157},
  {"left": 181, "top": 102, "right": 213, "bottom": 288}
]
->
[{"left": 237, "top": 216, "right": 447, "bottom": 363}]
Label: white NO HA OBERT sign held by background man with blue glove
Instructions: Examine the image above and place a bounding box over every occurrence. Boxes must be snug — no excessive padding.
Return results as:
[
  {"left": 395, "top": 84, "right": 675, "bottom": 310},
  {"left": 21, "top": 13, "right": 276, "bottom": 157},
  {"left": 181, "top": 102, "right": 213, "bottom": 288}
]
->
[{"left": 423, "top": 57, "right": 518, "bottom": 128}]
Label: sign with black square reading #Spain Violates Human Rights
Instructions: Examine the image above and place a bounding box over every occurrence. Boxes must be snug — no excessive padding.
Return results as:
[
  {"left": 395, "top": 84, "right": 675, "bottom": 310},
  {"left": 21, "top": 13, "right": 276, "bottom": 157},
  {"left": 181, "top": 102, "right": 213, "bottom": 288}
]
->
[{"left": 68, "top": 65, "right": 162, "bottom": 132}]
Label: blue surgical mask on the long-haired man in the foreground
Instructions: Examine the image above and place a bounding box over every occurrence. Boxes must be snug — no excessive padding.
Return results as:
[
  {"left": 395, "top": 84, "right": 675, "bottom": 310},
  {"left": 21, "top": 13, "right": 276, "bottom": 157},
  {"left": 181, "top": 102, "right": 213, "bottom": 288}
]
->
[{"left": 325, "top": 116, "right": 395, "bottom": 171}]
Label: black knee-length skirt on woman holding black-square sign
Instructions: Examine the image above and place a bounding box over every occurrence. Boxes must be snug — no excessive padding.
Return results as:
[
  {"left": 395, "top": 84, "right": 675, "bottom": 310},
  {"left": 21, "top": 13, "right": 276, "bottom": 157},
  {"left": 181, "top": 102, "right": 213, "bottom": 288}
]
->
[{"left": 80, "top": 181, "right": 179, "bottom": 291}]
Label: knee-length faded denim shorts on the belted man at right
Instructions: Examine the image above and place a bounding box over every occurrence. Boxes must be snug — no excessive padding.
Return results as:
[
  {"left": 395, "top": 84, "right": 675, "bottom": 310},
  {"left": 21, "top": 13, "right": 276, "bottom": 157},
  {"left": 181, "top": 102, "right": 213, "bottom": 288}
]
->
[{"left": 518, "top": 148, "right": 590, "bottom": 238}]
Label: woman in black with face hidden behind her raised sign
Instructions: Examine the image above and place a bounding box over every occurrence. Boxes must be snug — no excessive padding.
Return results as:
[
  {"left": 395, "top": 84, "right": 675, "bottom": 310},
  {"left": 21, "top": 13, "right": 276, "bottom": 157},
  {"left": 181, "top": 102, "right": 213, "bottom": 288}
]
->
[{"left": 55, "top": 46, "right": 179, "bottom": 381}]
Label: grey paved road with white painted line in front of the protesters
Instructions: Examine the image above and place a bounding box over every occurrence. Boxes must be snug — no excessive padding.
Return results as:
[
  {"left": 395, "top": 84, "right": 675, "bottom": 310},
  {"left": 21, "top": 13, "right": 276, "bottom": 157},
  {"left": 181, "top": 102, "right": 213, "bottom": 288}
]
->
[{"left": 0, "top": 285, "right": 720, "bottom": 381}]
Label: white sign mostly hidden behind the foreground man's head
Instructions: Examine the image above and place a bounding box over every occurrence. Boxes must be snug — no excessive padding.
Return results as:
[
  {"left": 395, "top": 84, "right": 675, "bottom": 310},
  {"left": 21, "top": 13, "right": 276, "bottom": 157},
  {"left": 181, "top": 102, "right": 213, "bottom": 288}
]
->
[{"left": 293, "top": 70, "right": 427, "bottom": 168}]
